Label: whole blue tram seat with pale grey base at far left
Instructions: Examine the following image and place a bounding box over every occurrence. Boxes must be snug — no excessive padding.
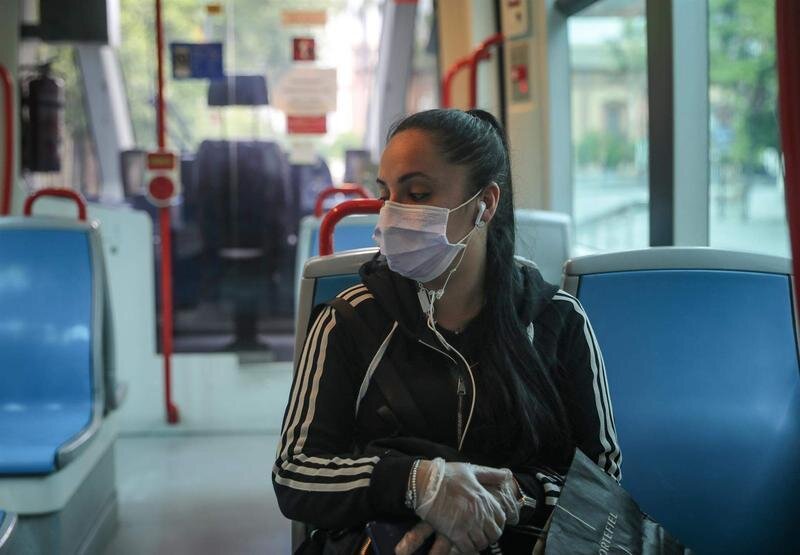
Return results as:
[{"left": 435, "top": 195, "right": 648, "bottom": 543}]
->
[{"left": 0, "top": 217, "right": 118, "bottom": 553}]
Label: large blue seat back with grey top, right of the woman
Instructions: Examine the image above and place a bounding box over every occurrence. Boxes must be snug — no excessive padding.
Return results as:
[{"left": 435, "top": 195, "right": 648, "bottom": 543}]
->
[{"left": 563, "top": 248, "right": 800, "bottom": 553}]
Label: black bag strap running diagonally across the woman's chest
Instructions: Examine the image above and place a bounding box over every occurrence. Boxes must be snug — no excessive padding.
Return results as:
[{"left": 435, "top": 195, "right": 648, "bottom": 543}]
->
[{"left": 325, "top": 297, "right": 428, "bottom": 436}]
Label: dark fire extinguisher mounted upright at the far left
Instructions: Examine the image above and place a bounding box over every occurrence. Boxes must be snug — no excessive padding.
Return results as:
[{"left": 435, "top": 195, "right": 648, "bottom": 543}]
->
[{"left": 22, "top": 64, "right": 64, "bottom": 172}]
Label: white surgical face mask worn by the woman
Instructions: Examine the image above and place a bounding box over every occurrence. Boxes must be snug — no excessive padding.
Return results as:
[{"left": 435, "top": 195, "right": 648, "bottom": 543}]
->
[{"left": 372, "top": 191, "right": 486, "bottom": 283}]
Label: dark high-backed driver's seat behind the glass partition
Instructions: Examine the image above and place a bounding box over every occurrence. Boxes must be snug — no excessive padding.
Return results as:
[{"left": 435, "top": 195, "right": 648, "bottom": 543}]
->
[{"left": 195, "top": 140, "right": 294, "bottom": 338}]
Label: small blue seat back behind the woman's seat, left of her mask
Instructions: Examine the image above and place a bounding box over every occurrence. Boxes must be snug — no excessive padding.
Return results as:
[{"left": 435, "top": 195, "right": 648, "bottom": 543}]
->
[{"left": 295, "top": 214, "right": 378, "bottom": 306}]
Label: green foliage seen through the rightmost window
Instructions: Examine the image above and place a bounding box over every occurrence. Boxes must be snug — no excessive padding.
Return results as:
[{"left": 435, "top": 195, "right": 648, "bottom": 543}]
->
[{"left": 708, "top": 0, "right": 780, "bottom": 173}]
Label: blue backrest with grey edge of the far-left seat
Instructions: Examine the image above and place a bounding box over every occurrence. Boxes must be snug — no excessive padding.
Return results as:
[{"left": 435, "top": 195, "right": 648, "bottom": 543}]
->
[{"left": 0, "top": 217, "right": 105, "bottom": 465}]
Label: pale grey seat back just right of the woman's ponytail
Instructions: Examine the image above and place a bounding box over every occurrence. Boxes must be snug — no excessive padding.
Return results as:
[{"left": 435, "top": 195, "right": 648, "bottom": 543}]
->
[{"left": 514, "top": 209, "right": 572, "bottom": 283}]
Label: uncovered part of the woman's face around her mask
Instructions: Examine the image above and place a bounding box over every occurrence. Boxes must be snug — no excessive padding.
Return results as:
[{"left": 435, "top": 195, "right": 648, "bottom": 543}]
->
[{"left": 378, "top": 129, "right": 480, "bottom": 243}]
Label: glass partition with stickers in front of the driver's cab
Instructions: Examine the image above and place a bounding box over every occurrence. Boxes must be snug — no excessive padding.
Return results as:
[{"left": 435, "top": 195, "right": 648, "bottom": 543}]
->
[{"left": 120, "top": 0, "right": 381, "bottom": 360}]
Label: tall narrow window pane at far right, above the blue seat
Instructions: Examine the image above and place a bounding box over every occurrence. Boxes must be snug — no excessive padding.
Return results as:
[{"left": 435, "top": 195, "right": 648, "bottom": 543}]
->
[{"left": 708, "top": 0, "right": 789, "bottom": 256}]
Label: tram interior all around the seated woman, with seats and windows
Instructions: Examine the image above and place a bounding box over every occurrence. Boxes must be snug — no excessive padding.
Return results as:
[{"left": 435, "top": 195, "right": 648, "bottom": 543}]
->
[{"left": 0, "top": 0, "right": 800, "bottom": 555}]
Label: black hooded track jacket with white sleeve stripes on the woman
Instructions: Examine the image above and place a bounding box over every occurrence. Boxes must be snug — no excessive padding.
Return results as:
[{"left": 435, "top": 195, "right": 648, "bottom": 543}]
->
[{"left": 272, "top": 259, "right": 621, "bottom": 552}]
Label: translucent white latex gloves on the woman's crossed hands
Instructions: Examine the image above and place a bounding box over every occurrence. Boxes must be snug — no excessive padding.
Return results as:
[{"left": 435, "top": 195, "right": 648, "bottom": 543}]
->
[{"left": 395, "top": 458, "right": 507, "bottom": 555}]
